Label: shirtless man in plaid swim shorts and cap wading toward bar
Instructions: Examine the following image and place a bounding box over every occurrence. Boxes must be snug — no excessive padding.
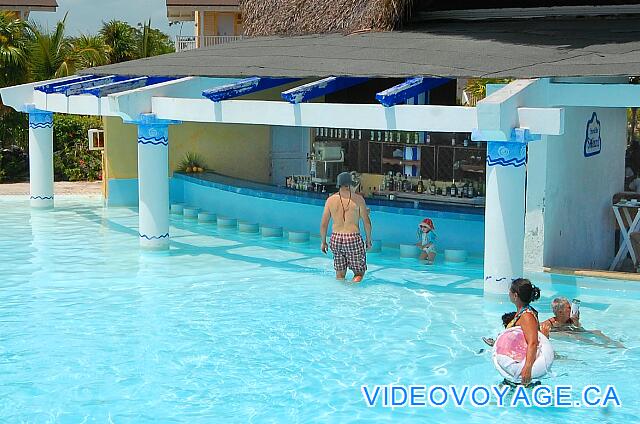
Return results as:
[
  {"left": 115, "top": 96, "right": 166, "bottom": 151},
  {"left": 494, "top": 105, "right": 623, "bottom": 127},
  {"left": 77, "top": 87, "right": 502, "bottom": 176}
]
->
[{"left": 320, "top": 172, "right": 371, "bottom": 283}]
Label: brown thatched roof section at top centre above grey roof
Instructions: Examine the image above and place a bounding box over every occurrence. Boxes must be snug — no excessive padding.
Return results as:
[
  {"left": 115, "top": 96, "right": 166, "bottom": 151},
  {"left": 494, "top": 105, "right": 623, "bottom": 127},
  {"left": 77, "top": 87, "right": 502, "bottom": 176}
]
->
[{"left": 240, "top": 0, "right": 414, "bottom": 36}]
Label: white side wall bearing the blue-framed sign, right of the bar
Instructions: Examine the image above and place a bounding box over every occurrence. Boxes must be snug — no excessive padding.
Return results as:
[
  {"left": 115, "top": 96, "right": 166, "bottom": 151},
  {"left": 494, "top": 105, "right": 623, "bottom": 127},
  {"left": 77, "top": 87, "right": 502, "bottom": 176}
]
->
[{"left": 527, "top": 108, "right": 626, "bottom": 269}]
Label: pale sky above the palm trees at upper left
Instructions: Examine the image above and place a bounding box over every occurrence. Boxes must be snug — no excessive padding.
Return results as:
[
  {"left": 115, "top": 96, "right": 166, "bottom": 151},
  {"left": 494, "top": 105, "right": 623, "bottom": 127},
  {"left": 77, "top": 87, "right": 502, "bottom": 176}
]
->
[{"left": 29, "top": 0, "right": 193, "bottom": 38}]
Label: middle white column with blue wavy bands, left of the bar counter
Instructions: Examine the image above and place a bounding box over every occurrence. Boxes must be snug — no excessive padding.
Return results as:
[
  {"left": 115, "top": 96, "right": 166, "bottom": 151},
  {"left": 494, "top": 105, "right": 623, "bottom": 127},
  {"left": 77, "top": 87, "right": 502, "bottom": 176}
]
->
[{"left": 138, "top": 114, "right": 169, "bottom": 250}]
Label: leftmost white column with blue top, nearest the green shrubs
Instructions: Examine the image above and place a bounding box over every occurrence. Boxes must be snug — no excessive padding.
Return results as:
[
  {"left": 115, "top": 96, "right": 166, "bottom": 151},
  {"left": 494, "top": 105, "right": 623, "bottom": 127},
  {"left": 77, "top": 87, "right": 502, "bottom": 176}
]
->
[{"left": 29, "top": 110, "right": 53, "bottom": 208}]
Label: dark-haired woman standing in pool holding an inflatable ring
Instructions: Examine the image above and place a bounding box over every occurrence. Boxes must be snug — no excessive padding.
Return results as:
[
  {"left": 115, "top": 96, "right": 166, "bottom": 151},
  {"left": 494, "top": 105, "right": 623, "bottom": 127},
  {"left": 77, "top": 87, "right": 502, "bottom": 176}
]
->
[{"left": 507, "top": 278, "right": 540, "bottom": 385}]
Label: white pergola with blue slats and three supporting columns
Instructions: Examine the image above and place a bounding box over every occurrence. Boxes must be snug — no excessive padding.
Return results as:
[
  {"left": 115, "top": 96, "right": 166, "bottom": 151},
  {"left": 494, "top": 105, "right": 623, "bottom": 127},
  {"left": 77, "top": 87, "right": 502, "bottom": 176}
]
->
[{"left": 0, "top": 15, "right": 640, "bottom": 293}]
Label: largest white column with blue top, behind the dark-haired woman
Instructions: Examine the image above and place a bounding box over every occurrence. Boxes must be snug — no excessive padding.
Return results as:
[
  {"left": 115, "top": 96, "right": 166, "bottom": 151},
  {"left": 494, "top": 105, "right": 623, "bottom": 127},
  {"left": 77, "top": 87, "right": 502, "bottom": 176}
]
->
[{"left": 484, "top": 142, "right": 527, "bottom": 294}]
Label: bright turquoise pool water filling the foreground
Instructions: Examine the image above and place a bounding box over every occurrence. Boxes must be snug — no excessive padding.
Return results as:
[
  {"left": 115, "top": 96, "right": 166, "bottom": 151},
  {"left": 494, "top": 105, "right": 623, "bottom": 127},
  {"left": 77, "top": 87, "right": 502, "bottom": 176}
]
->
[{"left": 0, "top": 197, "right": 640, "bottom": 423}]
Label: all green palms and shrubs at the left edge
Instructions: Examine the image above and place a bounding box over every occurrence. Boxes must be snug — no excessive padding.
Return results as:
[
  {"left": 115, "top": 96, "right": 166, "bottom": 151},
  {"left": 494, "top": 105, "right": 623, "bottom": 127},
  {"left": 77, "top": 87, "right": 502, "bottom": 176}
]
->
[{"left": 0, "top": 11, "right": 174, "bottom": 180}]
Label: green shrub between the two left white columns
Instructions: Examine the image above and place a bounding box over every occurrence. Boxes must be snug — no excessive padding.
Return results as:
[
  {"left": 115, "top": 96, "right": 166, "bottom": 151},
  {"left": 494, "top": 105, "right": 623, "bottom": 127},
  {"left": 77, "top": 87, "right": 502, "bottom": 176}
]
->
[{"left": 53, "top": 114, "right": 102, "bottom": 181}]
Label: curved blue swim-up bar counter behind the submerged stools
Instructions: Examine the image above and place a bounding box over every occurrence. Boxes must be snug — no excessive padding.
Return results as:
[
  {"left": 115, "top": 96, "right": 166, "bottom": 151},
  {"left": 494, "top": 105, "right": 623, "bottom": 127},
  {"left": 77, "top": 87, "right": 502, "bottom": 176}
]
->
[{"left": 171, "top": 172, "right": 484, "bottom": 253}]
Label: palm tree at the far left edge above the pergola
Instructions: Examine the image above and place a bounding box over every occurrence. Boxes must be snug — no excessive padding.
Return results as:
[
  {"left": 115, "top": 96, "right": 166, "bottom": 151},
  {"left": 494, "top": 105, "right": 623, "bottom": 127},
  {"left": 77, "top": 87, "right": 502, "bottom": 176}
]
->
[{"left": 0, "top": 11, "right": 29, "bottom": 87}]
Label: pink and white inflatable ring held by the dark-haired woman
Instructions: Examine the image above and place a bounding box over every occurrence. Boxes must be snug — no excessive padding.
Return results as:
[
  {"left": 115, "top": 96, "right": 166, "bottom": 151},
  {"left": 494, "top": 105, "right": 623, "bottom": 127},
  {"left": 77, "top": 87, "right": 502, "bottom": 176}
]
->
[{"left": 493, "top": 327, "right": 554, "bottom": 383}]
